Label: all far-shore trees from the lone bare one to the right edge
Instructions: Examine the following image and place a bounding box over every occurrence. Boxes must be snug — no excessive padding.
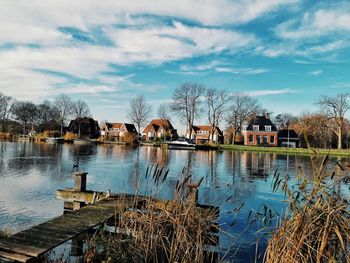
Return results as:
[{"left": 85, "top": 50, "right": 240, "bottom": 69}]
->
[{"left": 128, "top": 83, "right": 350, "bottom": 149}]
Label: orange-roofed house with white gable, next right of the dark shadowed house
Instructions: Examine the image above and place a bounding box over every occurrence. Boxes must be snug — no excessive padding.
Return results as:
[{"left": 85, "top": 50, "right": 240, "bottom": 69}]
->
[{"left": 101, "top": 122, "right": 138, "bottom": 143}]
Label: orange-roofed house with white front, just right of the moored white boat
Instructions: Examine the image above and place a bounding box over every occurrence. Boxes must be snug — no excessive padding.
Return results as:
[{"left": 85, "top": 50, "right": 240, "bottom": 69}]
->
[{"left": 186, "top": 125, "right": 224, "bottom": 144}]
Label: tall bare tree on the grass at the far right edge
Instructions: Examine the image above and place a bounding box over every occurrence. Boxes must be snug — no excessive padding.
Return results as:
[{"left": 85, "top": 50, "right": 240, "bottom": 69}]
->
[{"left": 317, "top": 93, "right": 350, "bottom": 149}]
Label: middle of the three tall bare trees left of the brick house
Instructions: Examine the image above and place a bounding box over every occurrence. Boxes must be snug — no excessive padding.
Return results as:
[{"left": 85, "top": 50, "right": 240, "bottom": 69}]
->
[{"left": 205, "top": 88, "right": 230, "bottom": 142}]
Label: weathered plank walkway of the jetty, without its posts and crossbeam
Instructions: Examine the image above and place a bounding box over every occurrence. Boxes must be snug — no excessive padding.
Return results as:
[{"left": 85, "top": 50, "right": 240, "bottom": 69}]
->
[{"left": 0, "top": 196, "right": 133, "bottom": 262}]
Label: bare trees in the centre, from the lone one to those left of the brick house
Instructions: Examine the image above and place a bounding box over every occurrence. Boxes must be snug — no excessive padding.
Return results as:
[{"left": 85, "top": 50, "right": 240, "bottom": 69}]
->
[{"left": 128, "top": 83, "right": 264, "bottom": 143}]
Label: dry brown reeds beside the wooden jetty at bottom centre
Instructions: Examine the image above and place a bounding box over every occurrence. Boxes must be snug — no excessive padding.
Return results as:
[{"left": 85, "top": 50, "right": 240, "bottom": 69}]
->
[{"left": 87, "top": 167, "right": 219, "bottom": 262}]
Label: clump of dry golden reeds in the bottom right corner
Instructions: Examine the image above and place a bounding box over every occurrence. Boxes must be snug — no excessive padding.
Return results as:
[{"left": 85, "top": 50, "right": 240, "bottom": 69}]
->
[{"left": 264, "top": 155, "right": 350, "bottom": 263}]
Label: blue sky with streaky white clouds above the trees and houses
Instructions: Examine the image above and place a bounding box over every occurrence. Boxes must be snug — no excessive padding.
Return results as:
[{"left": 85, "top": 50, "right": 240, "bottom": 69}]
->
[{"left": 0, "top": 0, "right": 350, "bottom": 131}]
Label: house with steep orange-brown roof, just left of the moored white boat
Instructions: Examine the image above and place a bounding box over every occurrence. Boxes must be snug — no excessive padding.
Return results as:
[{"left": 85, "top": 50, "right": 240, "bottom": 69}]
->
[{"left": 143, "top": 119, "right": 178, "bottom": 141}]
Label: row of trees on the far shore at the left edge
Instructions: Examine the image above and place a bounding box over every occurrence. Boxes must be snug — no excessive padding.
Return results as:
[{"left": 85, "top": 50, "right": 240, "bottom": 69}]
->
[{"left": 0, "top": 92, "right": 90, "bottom": 135}]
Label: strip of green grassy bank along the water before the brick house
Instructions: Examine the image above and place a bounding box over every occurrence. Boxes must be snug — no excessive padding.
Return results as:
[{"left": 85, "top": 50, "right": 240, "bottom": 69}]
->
[{"left": 216, "top": 144, "right": 350, "bottom": 156}]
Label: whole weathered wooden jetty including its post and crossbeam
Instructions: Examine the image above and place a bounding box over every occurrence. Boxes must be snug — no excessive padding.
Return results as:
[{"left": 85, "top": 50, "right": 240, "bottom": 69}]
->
[{"left": 0, "top": 172, "right": 219, "bottom": 262}]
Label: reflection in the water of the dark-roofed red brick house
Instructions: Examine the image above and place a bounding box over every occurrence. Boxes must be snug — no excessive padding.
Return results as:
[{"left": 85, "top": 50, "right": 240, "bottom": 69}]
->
[{"left": 241, "top": 152, "right": 277, "bottom": 177}]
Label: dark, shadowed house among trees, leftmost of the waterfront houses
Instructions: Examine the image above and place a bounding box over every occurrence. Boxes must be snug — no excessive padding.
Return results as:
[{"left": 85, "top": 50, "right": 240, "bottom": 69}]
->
[{"left": 67, "top": 117, "right": 100, "bottom": 139}]
